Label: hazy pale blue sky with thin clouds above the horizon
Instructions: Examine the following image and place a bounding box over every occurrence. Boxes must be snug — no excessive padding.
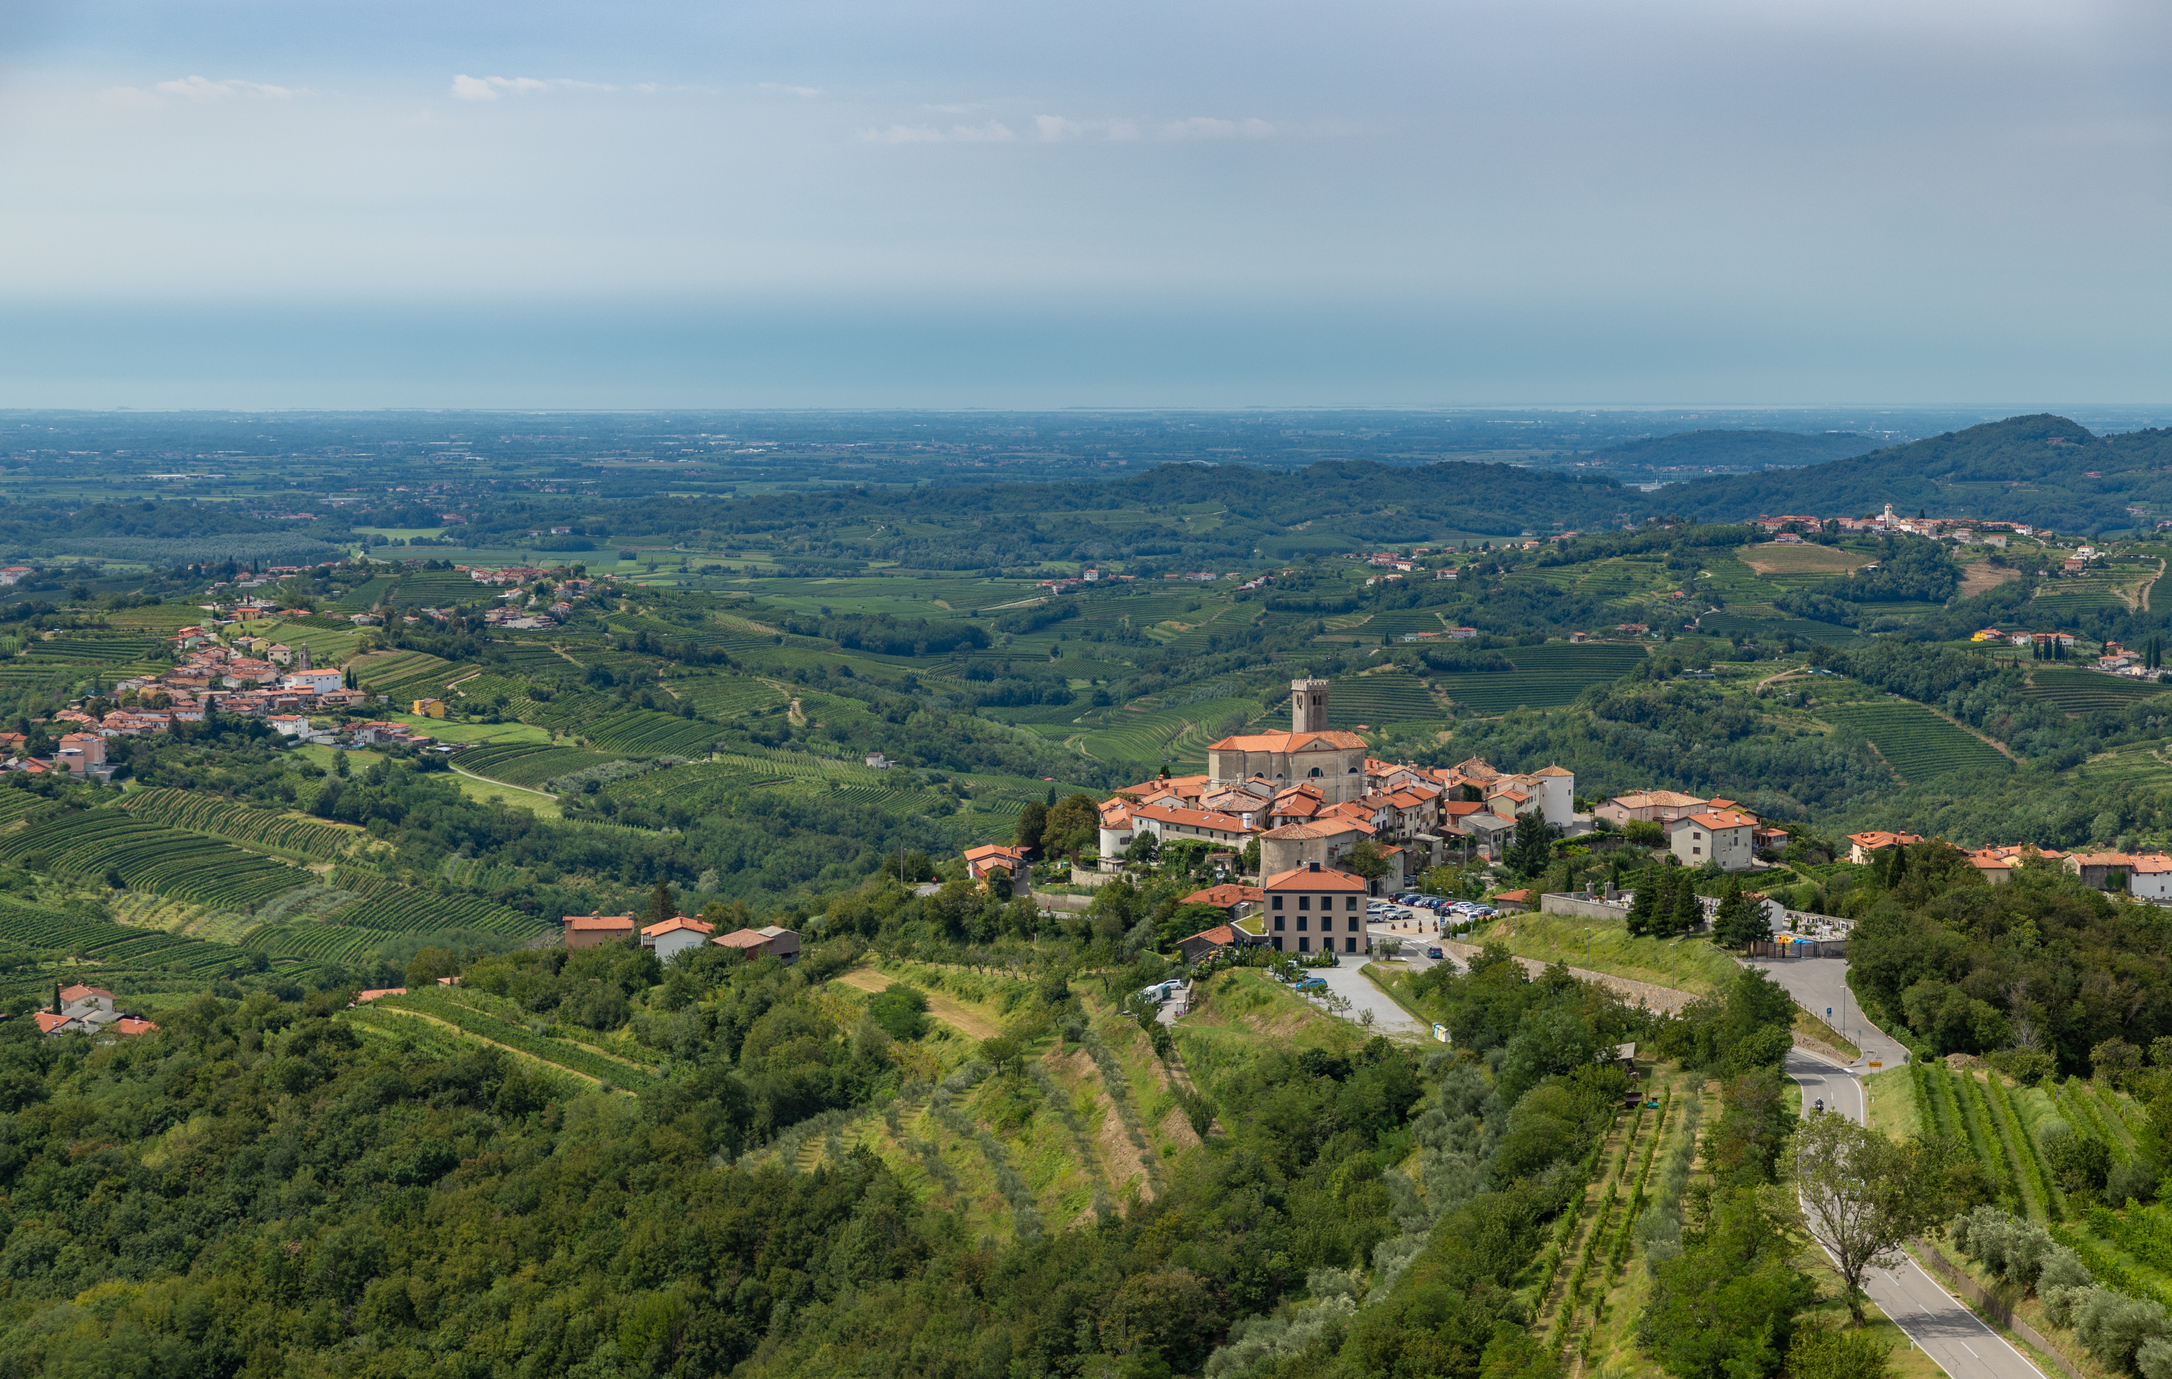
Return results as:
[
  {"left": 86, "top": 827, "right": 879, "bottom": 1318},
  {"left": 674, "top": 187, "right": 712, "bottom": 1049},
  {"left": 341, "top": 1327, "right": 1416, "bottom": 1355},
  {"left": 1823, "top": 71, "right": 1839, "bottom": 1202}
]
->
[{"left": 0, "top": 0, "right": 2172, "bottom": 406}]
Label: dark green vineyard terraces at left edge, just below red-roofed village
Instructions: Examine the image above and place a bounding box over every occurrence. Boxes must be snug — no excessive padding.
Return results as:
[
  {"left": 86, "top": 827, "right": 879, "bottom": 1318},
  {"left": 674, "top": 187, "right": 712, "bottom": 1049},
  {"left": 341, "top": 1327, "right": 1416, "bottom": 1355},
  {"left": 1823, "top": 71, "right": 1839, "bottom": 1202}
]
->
[{"left": 0, "top": 810, "right": 311, "bottom": 910}]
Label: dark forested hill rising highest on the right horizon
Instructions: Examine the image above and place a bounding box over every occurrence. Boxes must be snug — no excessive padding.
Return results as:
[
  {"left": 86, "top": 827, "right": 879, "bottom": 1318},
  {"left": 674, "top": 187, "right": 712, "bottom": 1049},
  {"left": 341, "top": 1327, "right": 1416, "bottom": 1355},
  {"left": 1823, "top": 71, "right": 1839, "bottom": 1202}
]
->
[{"left": 1655, "top": 415, "right": 2172, "bottom": 532}]
